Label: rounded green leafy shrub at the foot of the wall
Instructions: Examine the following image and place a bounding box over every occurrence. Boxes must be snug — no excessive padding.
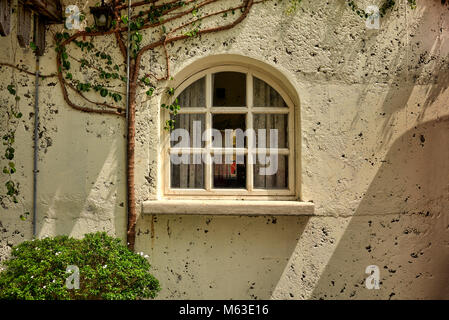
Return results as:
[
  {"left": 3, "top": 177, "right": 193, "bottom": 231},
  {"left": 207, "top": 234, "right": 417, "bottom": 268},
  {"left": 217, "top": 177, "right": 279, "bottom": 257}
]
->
[{"left": 0, "top": 232, "right": 160, "bottom": 300}]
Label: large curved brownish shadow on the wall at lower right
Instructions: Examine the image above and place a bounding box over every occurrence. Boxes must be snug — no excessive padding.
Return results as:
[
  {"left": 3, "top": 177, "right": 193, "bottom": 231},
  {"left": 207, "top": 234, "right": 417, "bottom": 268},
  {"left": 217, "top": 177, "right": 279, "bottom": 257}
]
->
[{"left": 312, "top": 116, "right": 449, "bottom": 299}]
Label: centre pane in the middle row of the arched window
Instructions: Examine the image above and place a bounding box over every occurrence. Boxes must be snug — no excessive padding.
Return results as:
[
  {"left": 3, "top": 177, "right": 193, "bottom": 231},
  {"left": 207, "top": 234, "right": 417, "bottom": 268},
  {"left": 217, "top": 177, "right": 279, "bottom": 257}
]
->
[{"left": 212, "top": 114, "right": 246, "bottom": 148}]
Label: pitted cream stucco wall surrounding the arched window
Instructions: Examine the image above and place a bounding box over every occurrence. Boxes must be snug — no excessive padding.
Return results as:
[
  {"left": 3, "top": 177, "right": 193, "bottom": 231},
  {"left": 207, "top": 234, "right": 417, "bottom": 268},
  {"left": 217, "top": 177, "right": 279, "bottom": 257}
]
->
[{"left": 0, "top": 0, "right": 449, "bottom": 299}]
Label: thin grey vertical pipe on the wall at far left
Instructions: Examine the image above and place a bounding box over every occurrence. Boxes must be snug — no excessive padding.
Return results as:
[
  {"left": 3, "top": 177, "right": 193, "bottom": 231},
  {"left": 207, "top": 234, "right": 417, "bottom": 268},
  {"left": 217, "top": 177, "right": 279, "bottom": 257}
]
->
[{"left": 33, "top": 55, "right": 39, "bottom": 238}]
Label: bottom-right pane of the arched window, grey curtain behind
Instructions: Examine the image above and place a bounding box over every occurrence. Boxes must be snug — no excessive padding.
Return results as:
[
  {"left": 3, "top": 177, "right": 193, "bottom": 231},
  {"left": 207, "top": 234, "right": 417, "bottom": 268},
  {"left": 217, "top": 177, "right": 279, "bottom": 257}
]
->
[{"left": 254, "top": 155, "right": 288, "bottom": 189}]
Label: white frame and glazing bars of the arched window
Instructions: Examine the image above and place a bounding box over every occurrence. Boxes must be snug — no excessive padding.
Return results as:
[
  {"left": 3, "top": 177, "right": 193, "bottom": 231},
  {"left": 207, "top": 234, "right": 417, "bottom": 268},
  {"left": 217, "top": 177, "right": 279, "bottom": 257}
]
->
[{"left": 160, "top": 65, "right": 299, "bottom": 200}]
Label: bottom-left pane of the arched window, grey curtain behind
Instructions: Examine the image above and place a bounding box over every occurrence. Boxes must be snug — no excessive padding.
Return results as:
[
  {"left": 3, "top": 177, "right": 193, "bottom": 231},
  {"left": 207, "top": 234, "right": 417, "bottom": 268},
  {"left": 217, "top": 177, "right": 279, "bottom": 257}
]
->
[{"left": 170, "top": 154, "right": 204, "bottom": 189}]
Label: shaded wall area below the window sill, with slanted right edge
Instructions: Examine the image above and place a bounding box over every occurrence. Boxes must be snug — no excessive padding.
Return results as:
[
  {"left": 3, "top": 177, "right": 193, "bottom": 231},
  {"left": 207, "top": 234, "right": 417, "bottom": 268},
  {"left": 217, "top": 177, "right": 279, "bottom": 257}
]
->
[{"left": 136, "top": 215, "right": 308, "bottom": 299}]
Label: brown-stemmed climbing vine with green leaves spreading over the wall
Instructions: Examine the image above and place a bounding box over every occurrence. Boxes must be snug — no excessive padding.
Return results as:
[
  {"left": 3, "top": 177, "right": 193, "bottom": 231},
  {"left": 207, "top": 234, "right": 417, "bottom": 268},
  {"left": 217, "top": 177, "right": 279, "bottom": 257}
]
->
[{"left": 0, "top": 0, "right": 416, "bottom": 249}]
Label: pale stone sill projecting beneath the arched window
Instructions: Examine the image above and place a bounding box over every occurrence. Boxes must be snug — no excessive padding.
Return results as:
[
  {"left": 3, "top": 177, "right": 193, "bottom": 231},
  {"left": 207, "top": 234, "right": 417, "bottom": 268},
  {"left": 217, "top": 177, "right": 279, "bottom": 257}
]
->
[{"left": 142, "top": 200, "right": 315, "bottom": 216}]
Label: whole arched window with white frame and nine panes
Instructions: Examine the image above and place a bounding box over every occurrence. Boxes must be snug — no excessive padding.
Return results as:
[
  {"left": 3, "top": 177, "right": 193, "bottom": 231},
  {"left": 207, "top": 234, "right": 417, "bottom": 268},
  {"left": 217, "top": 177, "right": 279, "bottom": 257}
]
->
[{"left": 163, "top": 66, "right": 296, "bottom": 199}]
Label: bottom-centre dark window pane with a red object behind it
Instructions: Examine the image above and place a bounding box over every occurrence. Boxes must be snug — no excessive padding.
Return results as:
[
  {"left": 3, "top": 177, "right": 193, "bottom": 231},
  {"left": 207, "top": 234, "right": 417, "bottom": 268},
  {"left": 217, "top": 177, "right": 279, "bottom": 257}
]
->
[{"left": 212, "top": 154, "right": 246, "bottom": 189}]
